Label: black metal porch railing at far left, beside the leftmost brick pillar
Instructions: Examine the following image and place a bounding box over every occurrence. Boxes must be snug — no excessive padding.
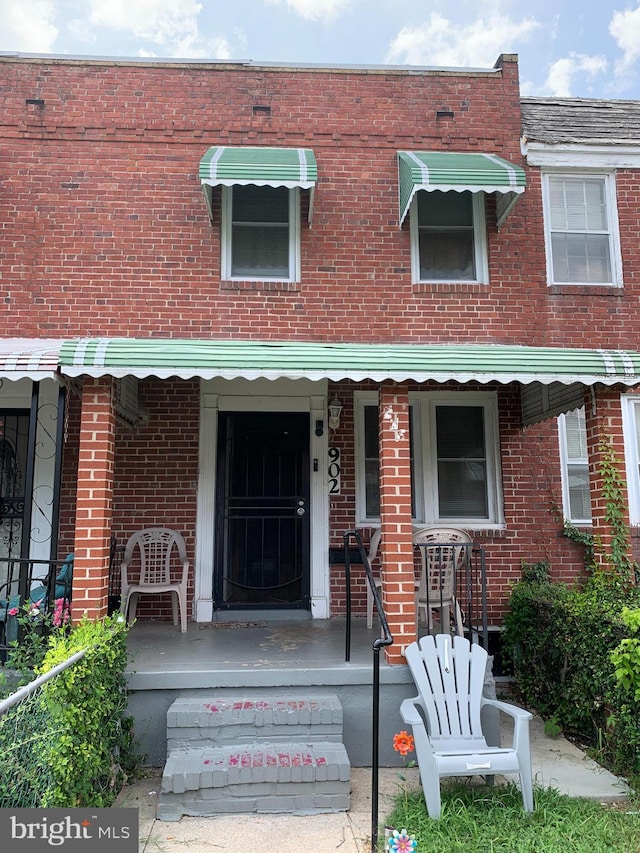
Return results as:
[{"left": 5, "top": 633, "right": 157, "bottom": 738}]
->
[{"left": 0, "top": 555, "right": 73, "bottom": 663}]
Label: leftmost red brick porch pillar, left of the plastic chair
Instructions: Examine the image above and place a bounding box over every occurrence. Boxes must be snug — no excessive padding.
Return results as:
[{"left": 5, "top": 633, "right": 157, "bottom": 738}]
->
[{"left": 73, "top": 377, "right": 115, "bottom": 621}]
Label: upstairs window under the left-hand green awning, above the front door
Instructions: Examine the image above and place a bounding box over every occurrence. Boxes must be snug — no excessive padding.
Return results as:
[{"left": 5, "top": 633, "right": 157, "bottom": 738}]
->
[{"left": 222, "top": 185, "right": 300, "bottom": 281}]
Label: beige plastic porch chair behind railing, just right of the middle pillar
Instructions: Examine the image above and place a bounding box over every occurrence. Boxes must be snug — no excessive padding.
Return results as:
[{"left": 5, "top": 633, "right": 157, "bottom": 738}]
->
[{"left": 413, "top": 527, "right": 473, "bottom": 636}]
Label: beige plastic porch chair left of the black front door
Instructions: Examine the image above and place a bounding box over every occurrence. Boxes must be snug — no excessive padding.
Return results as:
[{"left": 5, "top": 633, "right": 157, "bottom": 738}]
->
[{"left": 120, "top": 527, "right": 189, "bottom": 634}]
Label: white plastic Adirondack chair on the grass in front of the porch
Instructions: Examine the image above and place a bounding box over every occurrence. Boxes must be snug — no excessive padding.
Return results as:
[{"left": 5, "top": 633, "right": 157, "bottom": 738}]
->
[{"left": 400, "top": 634, "right": 533, "bottom": 819}]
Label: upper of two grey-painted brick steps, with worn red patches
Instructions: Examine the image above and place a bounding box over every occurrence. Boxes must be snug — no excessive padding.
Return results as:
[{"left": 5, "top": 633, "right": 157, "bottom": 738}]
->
[{"left": 167, "top": 694, "right": 343, "bottom": 751}]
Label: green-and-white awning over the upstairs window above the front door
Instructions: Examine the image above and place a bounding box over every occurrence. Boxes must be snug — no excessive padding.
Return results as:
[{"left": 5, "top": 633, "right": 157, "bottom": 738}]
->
[{"left": 199, "top": 146, "right": 318, "bottom": 221}]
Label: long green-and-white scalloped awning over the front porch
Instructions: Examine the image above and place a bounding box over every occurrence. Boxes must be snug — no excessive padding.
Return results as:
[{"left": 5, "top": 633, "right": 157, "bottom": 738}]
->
[{"left": 60, "top": 338, "right": 640, "bottom": 387}]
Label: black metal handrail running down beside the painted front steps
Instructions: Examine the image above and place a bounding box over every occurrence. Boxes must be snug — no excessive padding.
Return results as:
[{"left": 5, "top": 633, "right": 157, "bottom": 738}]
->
[{"left": 343, "top": 530, "right": 393, "bottom": 853}]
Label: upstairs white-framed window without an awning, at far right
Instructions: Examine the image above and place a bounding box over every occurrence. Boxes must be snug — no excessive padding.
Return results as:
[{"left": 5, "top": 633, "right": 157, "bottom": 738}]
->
[{"left": 543, "top": 173, "right": 622, "bottom": 286}]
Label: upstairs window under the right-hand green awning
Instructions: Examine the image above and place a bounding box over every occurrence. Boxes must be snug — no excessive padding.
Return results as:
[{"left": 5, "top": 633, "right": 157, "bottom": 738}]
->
[{"left": 410, "top": 190, "right": 488, "bottom": 282}]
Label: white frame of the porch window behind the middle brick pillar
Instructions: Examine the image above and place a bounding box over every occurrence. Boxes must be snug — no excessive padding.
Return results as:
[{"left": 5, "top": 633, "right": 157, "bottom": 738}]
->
[{"left": 354, "top": 391, "right": 504, "bottom": 530}]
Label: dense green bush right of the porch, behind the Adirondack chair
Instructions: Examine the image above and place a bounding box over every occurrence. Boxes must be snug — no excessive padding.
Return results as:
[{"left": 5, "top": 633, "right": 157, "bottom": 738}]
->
[{"left": 504, "top": 572, "right": 640, "bottom": 777}]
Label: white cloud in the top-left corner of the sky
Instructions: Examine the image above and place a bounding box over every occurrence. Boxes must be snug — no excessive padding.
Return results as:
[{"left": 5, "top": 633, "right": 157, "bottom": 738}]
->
[{"left": 0, "top": 0, "right": 58, "bottom": 53}]
